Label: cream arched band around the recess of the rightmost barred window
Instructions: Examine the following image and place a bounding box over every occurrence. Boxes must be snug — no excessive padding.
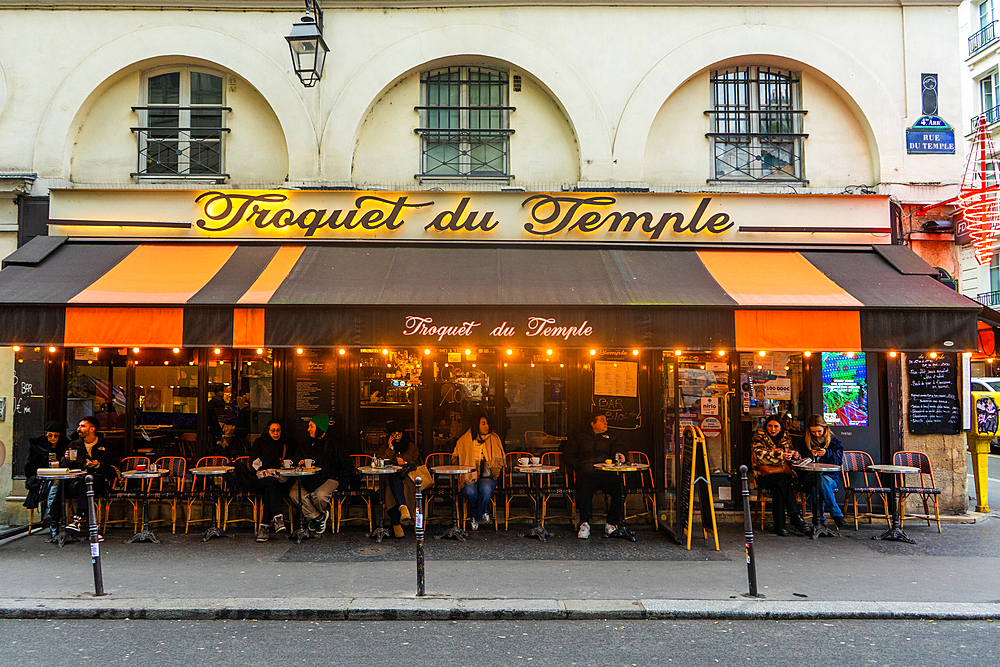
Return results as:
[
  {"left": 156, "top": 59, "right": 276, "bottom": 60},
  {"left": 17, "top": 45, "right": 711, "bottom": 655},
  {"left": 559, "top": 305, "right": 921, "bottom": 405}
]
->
[{"left": 614, "top": 25, "right": 892, "bottom": 180}]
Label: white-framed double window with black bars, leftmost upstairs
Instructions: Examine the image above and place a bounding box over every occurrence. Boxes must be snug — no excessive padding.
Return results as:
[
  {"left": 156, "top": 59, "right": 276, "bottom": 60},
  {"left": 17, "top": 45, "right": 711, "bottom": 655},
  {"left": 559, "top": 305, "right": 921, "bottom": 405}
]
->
[{"left": 132, "top": 67, "right": 231, "bottom": 179}]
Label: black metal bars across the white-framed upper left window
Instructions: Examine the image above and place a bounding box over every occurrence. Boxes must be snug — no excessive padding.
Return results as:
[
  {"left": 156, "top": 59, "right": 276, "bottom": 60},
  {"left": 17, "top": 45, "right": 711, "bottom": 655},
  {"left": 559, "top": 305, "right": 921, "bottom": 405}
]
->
[{"left": 131, "top": 105, "right": 232, "bottom": 178}]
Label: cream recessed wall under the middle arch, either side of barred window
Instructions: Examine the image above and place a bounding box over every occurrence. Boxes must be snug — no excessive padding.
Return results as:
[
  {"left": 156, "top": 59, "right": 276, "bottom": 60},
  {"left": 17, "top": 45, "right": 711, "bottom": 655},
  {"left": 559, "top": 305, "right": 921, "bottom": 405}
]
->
[{"left": 352, "top": 67, "right": 580, "bottom": 188}]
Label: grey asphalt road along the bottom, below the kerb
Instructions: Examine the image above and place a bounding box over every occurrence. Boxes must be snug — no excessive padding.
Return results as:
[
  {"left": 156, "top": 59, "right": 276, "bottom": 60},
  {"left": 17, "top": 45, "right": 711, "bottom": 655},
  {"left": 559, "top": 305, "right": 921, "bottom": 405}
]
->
[{"left": 0, "top": 619, "right": 1000, "bottom": 667}]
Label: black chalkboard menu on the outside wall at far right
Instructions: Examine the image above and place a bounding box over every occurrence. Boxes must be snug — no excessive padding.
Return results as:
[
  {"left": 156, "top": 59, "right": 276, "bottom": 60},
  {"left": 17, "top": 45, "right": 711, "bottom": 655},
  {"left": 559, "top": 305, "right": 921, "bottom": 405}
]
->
[{"left": 906, "top": 352, "right": 962, "bottom": 435}]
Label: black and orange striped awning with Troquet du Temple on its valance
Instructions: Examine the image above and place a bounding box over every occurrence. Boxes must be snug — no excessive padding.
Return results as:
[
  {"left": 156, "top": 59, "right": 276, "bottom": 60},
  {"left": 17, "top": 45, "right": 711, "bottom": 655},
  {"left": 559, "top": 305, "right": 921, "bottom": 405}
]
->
[{"left": 0, "top": 237, "right": 981, "bottom": 351}]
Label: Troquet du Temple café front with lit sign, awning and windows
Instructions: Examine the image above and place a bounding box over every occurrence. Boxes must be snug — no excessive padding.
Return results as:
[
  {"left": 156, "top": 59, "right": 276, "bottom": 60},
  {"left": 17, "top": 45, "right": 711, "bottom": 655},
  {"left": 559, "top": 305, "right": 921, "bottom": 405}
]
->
[{"left": 0, "top": 188, "right": 982, "bottom": 533}]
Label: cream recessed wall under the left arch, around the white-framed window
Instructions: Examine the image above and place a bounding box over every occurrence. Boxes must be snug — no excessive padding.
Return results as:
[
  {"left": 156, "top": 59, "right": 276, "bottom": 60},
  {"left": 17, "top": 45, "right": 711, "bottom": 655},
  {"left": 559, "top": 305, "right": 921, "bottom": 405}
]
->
[{"left": 70, "top": 59, "right": 288, "bottom": 186}]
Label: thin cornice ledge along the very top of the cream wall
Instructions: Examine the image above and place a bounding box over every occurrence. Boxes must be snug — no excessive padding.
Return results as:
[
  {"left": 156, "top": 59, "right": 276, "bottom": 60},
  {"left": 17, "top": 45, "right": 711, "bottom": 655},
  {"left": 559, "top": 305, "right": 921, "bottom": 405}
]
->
[{"left": 0, "top": 0, "right": 962, "bottom": 12}]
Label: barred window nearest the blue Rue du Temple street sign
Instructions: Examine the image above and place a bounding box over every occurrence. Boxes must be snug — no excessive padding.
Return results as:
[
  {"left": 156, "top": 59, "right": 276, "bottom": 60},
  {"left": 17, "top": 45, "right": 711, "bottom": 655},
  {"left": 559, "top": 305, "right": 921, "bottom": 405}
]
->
[{"left": 706, "top": 65, "right": 808, "bottom": 181}]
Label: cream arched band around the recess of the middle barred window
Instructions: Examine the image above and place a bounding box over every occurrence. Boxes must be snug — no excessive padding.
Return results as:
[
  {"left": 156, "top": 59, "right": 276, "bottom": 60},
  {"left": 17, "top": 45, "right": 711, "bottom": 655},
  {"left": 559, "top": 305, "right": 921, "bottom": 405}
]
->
[{"left": 322, "top": 25, "right": 611, "bottom": 181}]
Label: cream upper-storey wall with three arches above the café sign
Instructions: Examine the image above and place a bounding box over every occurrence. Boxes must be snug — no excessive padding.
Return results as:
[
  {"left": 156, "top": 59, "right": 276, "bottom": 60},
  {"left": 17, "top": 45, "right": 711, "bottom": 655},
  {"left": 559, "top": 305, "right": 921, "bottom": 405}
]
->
[{"left": 0, "top": 2, "right": 962, "bottom": 189}]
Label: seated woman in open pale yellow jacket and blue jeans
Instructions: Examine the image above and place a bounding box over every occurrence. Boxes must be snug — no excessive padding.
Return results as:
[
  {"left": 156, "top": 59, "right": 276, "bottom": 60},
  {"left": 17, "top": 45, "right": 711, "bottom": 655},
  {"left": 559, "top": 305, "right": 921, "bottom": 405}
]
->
[{"left": 451, "top": 415, "right": 504, "bottom": 530}]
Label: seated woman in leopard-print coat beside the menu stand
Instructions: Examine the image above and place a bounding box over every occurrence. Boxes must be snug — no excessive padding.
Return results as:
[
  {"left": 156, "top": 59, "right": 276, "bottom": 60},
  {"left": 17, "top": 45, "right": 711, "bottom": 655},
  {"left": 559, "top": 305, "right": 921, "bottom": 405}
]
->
[{"left": 751, "top": 416, "right": 806, "bottom": 537}]
